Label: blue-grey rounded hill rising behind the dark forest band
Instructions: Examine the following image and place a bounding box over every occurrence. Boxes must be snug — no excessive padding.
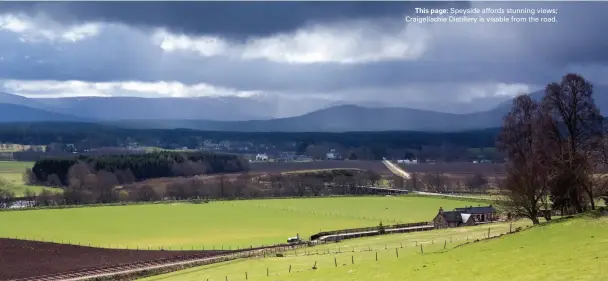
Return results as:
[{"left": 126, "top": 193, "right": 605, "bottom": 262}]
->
[{"left": 108, "top": 105, "right": 502, "bottom": 132}]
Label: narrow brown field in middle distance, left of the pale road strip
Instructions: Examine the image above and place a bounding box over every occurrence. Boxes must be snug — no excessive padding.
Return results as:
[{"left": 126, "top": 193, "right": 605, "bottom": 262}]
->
[{"left": 249, "top": 160, "right": 391, "bottom": 175}]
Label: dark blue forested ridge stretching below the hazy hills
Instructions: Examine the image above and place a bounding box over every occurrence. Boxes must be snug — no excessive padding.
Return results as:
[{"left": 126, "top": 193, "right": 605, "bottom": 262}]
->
[{"left": 0, "top": 122, "right": 499, "bottom": 149}]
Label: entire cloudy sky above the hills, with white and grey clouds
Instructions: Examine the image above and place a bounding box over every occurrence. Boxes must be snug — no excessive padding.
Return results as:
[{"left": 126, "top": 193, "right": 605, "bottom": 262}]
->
[{"left": 0, "top": 2, "right": 608, "bottom": 112}]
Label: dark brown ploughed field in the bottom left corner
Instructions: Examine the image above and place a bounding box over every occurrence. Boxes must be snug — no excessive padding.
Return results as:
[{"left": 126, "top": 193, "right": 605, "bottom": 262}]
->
[{"left": 0, "top": 238, "right": 229, "bottom": 280}]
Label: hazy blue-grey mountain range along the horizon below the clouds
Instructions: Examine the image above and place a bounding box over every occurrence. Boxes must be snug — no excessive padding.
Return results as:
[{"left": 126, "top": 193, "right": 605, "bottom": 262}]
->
[{"left": 0, "top": 86, "right": 608, "bottom": 132}]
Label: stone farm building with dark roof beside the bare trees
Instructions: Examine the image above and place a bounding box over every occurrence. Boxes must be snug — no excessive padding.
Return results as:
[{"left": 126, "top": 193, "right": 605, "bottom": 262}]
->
[{"left": 433, "top": 205, "right": 498, "bottom": 228}]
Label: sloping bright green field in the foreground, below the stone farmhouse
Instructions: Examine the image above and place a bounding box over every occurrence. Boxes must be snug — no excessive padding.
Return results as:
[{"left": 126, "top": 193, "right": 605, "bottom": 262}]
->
[{"left": 144, "top": 218, "right": 608, "bottom": 281}]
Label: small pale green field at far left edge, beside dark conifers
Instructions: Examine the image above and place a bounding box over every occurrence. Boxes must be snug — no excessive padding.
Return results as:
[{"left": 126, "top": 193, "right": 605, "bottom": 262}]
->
[{"left": 0, "top": 161, "right": 60, "bottom": 196}]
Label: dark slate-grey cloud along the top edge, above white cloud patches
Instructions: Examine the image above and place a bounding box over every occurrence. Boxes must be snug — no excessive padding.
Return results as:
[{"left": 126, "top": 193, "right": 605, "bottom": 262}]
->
[{"left": 0, "top": 1, "right": 469, "bottom": 38}]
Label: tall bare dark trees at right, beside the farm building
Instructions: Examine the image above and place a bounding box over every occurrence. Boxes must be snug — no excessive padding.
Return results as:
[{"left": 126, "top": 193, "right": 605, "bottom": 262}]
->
[{"left": 497, "top": 74, "right": 608, "bottom": 224}]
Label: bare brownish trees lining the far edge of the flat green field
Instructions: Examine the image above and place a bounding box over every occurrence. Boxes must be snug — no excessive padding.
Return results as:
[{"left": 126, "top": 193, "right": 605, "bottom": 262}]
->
[{"left": 0, "top": 167, "right": 381, "bottom": 207}]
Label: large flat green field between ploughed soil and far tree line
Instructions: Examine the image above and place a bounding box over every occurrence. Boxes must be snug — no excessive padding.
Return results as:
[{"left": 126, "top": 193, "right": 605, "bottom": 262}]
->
[{"left": 0, "top": 196, "right": 478, "bottom": 249}]
